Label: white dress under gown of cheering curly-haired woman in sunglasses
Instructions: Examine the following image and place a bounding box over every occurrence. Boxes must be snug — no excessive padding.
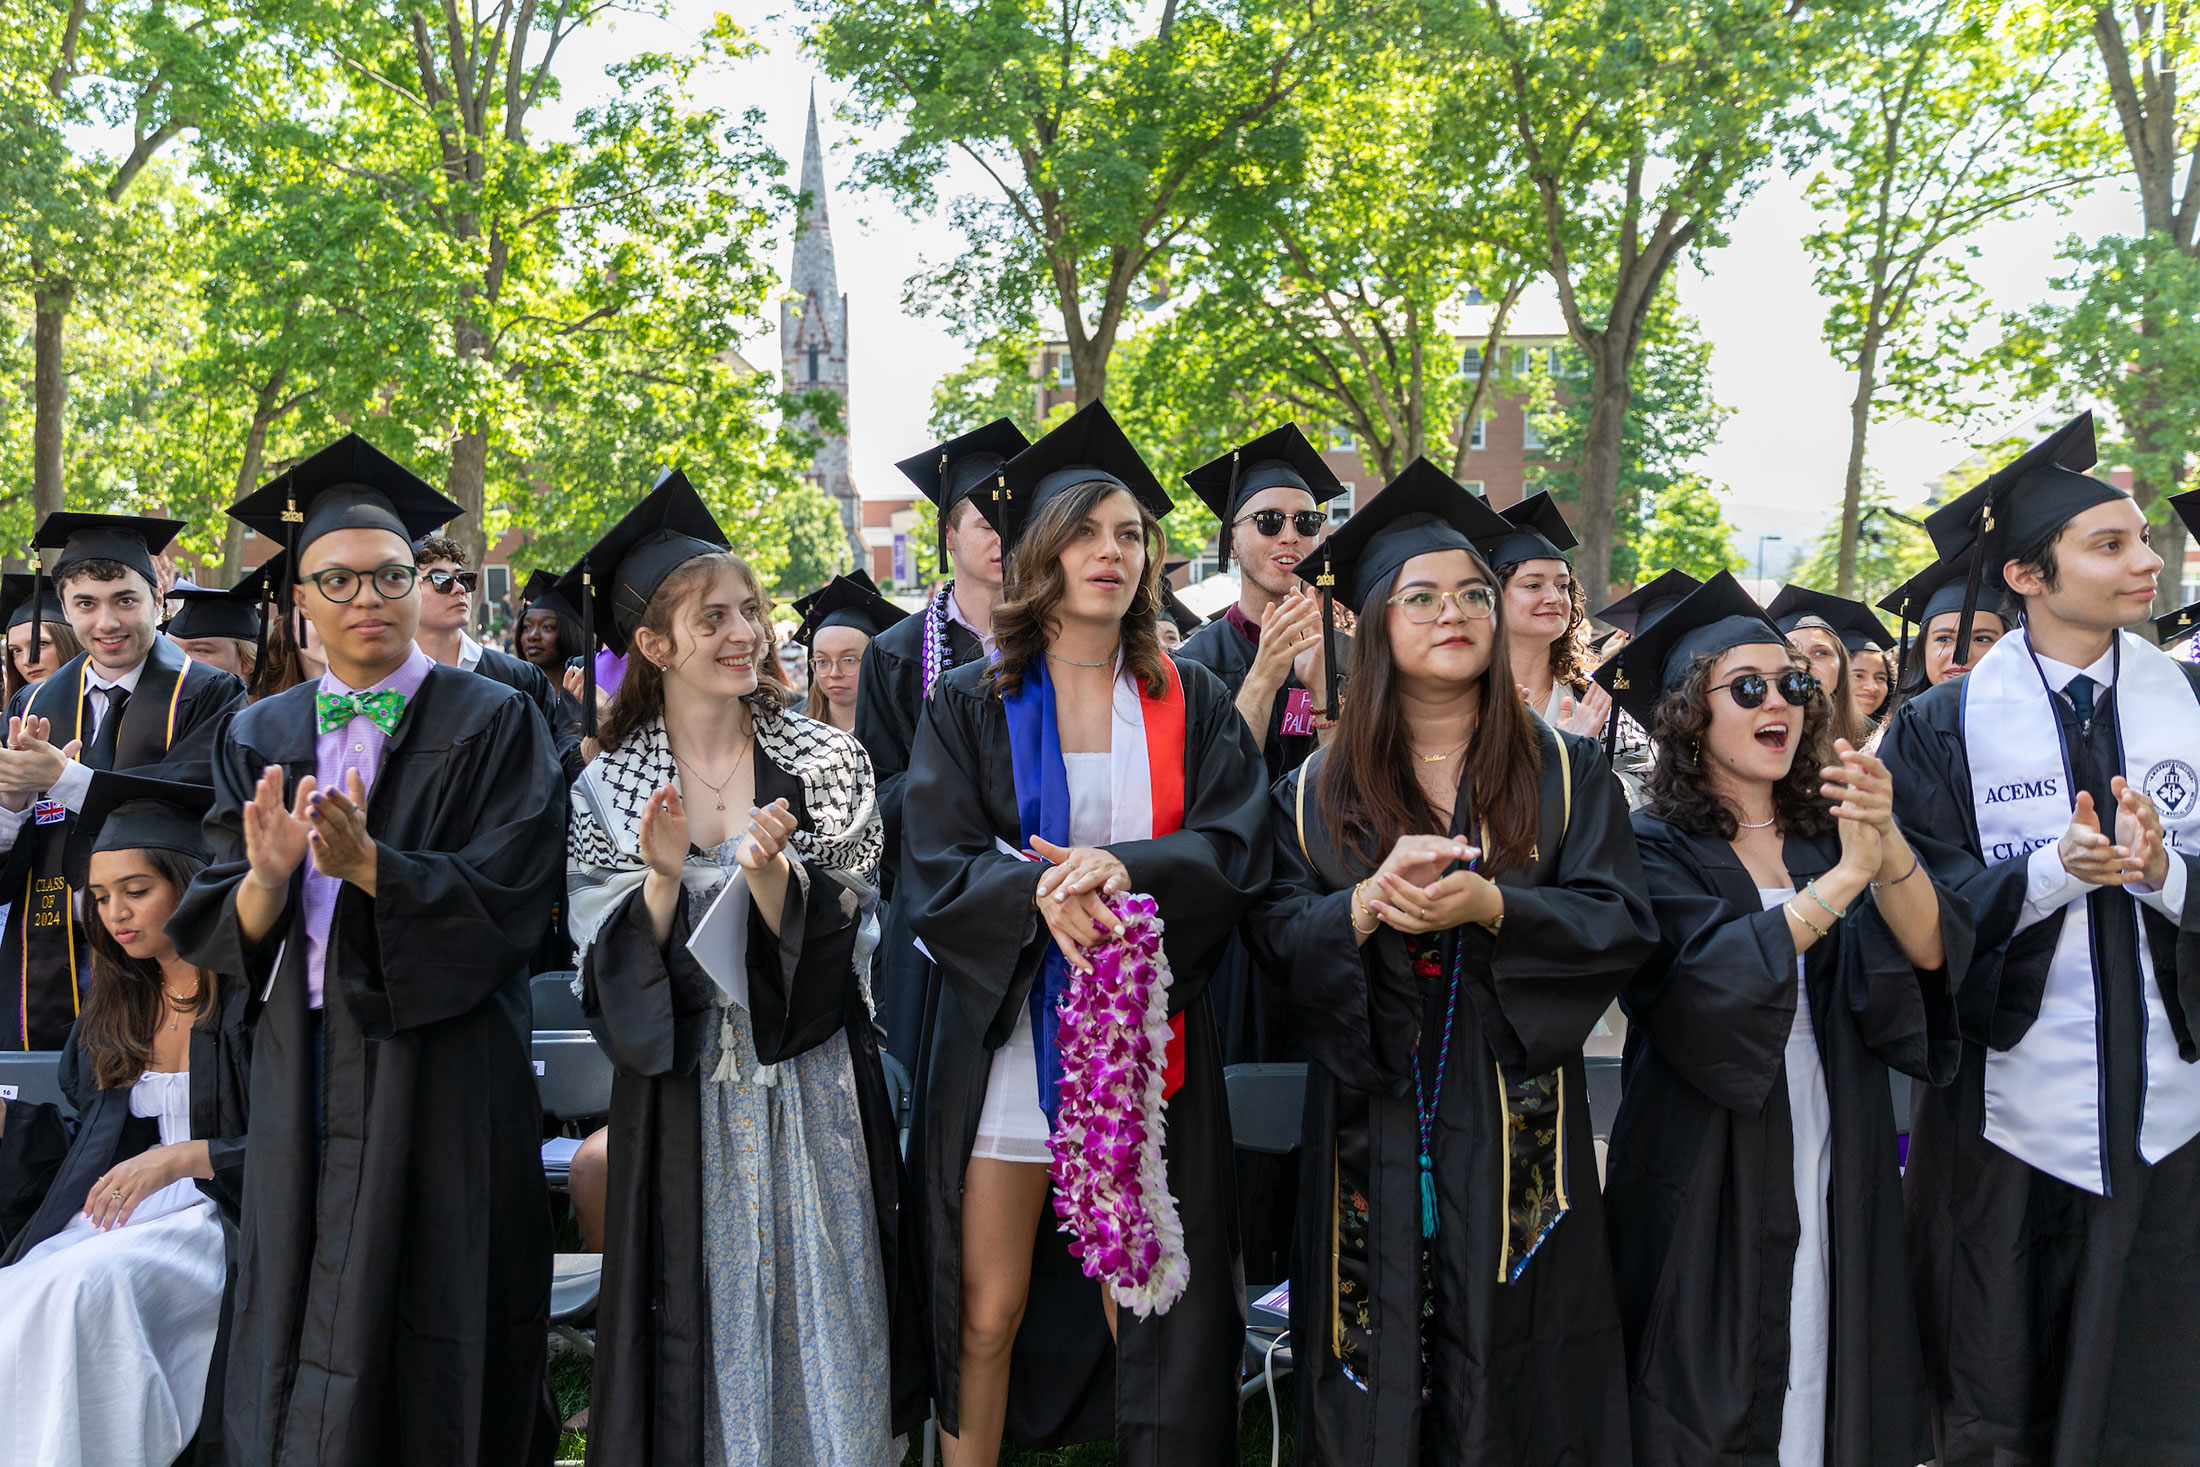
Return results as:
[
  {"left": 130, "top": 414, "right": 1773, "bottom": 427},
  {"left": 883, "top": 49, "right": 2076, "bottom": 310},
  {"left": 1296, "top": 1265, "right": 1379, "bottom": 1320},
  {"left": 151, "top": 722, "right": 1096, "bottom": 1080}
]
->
[{"left": 1758, "top": 886, "right": 1833, "bottom": 1467}]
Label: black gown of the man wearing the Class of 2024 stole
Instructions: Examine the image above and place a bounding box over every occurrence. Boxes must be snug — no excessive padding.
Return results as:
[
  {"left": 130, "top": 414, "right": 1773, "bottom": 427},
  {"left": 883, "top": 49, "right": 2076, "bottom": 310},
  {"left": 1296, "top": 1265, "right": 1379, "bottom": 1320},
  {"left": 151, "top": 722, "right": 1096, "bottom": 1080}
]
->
[{"left": 0, "top": 631, "right": 244, "bottom": 1049}]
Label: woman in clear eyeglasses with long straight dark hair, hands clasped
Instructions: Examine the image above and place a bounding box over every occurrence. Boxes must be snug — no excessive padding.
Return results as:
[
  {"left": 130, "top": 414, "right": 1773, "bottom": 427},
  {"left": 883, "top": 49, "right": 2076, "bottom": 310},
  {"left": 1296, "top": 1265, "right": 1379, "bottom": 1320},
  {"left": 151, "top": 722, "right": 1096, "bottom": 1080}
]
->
[{"left": 1245, "top": 460, "right": 1650, "bottom": 1467}]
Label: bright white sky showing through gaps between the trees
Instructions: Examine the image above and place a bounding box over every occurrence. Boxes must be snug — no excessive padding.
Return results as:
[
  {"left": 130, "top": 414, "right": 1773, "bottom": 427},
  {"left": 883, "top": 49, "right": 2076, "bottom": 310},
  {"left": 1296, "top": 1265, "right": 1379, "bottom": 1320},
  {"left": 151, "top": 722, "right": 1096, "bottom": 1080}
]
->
[{"left": 565, "top": 0, "right": 2136, "bottom": 565}]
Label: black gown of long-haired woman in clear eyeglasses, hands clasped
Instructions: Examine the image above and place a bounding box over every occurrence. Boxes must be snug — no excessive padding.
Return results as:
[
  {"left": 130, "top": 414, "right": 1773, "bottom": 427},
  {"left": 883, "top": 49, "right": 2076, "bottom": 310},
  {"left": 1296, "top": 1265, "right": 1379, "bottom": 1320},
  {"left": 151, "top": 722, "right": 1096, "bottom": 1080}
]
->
[{"left": 1245, "top": 721, "right": 1654, "bottom": 1467}]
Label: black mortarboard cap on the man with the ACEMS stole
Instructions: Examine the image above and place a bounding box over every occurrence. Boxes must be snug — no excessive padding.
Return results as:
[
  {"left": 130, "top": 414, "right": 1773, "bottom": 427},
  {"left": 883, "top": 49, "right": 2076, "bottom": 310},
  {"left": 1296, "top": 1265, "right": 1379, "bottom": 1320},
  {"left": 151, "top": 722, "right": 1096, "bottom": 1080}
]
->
[{"left": 1925, "top": 409, "right": 2130, "bottom": 664}]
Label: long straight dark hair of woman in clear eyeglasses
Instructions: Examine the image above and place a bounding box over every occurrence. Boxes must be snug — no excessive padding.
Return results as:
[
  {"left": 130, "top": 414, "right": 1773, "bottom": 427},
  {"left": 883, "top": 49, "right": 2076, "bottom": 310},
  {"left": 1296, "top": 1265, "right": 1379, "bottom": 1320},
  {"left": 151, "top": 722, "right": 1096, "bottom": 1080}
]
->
[{"left": 1316, "top": 552, "right": 1542, "bottom": 875}]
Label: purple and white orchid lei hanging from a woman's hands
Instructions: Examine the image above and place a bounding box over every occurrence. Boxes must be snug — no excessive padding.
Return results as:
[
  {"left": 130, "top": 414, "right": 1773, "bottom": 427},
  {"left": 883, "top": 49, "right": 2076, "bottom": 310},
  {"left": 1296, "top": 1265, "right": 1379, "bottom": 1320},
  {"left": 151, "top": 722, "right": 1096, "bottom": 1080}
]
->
[{"left": 1047, "top": 895, "right": 1190, "bottom": 1320}]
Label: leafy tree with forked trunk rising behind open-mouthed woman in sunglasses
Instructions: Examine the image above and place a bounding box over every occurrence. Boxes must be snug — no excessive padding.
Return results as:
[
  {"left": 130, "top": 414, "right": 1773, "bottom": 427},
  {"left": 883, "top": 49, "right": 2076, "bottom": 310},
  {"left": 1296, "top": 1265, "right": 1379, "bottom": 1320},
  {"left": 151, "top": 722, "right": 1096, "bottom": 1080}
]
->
[{"left": 1428, "top": 0, "right": 1848, "bottom": 592}]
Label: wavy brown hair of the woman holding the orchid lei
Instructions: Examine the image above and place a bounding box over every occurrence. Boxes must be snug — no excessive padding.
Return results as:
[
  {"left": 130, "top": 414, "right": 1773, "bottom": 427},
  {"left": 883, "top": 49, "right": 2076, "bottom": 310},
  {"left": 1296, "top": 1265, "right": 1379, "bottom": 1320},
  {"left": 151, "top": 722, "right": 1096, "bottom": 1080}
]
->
[{"left": 992, "top": 479, "right": 1168, "bottom": 697}]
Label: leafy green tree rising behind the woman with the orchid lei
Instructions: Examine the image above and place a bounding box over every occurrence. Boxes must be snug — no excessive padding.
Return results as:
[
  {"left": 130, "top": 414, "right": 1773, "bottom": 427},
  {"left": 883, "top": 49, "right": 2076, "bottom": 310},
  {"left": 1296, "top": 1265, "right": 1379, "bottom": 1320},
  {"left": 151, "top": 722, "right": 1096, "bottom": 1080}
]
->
[{"left": 803, "top": 0, "right": 1346, "bottom": 405}]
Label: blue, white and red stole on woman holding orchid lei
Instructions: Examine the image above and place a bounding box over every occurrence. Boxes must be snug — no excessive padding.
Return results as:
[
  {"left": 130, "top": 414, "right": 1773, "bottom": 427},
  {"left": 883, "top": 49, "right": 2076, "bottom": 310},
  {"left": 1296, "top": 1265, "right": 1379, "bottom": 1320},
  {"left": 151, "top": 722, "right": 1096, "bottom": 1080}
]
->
[{"left": 1001, "top": 658, "right": 1184, "bottom": 1126}]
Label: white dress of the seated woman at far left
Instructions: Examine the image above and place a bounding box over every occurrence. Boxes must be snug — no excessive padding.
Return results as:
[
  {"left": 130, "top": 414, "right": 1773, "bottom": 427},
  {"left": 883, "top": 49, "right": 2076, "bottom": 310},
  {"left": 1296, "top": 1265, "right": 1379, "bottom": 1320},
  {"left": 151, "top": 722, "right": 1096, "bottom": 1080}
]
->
[{"left": 0, "top": 1071, "right": 227, "bottom": 1467}]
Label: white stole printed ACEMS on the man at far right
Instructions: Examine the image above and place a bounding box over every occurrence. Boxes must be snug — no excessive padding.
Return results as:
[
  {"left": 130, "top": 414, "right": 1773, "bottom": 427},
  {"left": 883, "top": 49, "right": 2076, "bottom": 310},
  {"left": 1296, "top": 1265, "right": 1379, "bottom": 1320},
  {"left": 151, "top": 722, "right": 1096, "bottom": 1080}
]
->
[{"left": 1962, "top": 627, "right": 2200, "bottom": 1196}]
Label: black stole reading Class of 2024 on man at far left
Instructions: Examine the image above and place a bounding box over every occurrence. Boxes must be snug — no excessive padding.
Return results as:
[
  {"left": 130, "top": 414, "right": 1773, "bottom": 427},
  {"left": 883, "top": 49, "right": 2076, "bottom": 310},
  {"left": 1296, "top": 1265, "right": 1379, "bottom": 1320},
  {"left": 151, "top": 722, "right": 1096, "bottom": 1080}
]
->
[{"left": 9, "top": 636, "right": 191, "bottom": 1049}]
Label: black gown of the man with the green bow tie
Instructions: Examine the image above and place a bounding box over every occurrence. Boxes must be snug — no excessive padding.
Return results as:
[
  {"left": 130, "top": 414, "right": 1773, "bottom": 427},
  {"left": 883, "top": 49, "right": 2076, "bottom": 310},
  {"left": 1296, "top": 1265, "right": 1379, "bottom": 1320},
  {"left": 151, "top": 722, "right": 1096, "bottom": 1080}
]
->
[{"left": 169, "top": 666, "right": 565, "bottom": 1467}]
